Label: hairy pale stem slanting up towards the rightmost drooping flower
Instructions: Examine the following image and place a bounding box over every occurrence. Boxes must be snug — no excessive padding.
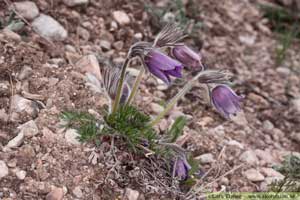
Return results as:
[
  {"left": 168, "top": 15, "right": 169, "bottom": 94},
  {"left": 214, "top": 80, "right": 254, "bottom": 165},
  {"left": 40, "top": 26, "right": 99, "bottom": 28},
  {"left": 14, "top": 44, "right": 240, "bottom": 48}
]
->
[{"left": 150, "top": 71, "right": 202, "bottom": 126}]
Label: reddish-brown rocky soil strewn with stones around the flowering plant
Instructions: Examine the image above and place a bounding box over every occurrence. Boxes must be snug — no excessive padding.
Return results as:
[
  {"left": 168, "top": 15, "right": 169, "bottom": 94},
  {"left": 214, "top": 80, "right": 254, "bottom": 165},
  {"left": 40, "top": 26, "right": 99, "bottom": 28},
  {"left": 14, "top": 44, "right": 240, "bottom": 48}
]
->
[{"left": 0, "top": 0, "right": 300, "bottom": 200}]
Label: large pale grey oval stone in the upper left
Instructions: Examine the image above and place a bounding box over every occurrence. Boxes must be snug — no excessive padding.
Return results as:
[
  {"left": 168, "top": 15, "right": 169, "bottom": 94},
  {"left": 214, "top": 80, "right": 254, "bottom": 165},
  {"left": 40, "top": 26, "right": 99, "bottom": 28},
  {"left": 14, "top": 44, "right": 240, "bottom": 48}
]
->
[{"left": 32, "top": 14, "right": 68, "bottom": 41}]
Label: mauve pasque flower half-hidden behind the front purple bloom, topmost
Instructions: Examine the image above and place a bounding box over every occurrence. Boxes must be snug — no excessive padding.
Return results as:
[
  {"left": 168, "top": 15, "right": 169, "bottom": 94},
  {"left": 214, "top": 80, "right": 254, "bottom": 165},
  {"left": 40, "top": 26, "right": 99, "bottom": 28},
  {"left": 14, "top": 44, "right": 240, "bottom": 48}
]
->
[{"left": 171, "top": 45, "right": 202, "bottom": 68}]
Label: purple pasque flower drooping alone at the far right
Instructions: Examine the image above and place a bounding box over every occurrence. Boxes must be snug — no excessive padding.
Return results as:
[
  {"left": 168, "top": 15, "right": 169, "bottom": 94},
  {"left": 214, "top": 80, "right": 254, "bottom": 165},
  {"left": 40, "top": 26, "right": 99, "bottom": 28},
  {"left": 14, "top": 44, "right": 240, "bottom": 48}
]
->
[{"left": 211, "top": 85, "right": 242, "bottom": 119}]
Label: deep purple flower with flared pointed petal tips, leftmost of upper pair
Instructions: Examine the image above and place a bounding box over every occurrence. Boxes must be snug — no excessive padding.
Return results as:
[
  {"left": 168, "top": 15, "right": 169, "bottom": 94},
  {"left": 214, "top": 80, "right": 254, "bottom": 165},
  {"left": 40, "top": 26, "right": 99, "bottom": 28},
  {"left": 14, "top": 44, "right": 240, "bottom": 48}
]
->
[{"left": 145, "top": 49, "right": 183, "bottom": 85}]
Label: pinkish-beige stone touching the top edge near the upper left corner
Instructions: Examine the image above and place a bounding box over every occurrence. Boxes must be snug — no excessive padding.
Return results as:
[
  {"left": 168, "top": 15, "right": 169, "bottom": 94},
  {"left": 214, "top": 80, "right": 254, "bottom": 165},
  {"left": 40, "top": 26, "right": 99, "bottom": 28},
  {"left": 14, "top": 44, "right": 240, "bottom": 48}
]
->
[{"left": 11, "top": 1, "right": 39, "bottom": 20}]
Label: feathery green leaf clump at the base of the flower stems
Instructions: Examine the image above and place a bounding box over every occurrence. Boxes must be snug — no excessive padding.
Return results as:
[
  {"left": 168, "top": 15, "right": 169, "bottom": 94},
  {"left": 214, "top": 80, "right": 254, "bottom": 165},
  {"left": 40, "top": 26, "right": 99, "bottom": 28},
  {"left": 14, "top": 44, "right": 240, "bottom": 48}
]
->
[{"left": 61, "top": 106, "right": 157, "bottom": 150}]
